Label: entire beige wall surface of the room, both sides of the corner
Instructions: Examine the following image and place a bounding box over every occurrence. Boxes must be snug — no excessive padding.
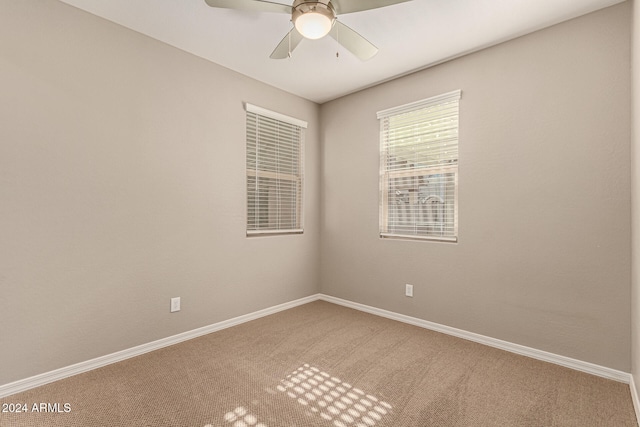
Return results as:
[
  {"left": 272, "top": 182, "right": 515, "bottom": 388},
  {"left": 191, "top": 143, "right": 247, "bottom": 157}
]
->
[{"left": 0, "top": 0, "right": 640, "bottom": 384}]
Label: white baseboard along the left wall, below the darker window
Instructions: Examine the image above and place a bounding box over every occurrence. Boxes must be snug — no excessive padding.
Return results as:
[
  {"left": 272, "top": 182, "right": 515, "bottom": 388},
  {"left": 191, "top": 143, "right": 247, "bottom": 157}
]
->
[{"left": 0, "top": 294, "right": 319, "bottom": 398}]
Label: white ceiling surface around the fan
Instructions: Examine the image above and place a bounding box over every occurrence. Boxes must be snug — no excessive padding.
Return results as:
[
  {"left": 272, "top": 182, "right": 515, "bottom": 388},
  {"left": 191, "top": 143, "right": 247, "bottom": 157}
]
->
[{"left": 61, "top": 0, "right": 623, "bottom": 103}]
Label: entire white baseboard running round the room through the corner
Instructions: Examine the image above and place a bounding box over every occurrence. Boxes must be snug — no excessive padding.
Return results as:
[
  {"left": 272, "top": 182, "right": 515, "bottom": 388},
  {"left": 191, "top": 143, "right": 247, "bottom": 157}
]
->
[{"left": 0, "top": 294, "right": 640, "bottom": 402}]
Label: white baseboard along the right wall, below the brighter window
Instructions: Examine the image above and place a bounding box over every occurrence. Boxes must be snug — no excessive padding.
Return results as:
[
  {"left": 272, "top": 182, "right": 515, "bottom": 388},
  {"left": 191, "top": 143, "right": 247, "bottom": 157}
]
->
[{"left": 319, "top": 294, "right": 631, "bottom": 384}]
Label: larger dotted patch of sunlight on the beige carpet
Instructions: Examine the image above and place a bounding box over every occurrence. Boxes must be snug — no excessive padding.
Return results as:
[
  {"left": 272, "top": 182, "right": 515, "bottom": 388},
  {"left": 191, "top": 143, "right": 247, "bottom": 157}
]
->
[{"left": 277, "top": 364, "right": 392, "bottom": 427}]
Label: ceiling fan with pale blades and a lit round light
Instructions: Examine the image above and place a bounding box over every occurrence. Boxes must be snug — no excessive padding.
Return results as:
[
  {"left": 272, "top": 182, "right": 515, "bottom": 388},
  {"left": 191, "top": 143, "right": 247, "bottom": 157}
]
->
[{"left": 205, "top": 0, "right": 410, "bottom": 61}]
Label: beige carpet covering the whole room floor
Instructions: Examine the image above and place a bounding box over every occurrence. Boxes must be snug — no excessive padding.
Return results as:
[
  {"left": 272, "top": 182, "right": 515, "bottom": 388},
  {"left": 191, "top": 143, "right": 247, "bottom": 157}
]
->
[{"left": 0, "top": 301, "right": 637, "bottom": 427}]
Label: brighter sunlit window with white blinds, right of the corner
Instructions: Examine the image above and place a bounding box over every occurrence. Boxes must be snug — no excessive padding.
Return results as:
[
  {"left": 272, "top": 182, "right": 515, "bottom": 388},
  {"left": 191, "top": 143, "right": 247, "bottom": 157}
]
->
[{"left": 378, "top": 90, "right": 460, "bottom": 242}]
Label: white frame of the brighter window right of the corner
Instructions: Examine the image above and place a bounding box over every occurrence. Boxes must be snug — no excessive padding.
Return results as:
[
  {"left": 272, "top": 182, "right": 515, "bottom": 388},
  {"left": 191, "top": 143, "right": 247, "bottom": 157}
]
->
[{"left": 377, "top": 90, "right": 462, "bottom": 243}]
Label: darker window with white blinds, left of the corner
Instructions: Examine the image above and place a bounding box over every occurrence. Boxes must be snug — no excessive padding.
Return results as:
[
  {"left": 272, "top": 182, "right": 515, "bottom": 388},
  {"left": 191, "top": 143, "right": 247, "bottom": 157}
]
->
[{"left": 246, "top": 104, "right": 307, "bottom": 236}]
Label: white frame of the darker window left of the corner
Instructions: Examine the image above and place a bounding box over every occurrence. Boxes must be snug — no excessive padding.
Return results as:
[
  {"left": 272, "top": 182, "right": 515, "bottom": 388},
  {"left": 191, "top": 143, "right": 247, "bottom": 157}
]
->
[{"left": 245, "top": 102, "right": 307, "bottom": 237}]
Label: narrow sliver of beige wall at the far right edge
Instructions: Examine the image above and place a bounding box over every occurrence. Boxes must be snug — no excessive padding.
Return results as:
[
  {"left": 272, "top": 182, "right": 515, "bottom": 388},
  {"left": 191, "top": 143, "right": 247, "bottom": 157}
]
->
[{"left": 631, "top": 0, "right": 640, "bottom": 409}]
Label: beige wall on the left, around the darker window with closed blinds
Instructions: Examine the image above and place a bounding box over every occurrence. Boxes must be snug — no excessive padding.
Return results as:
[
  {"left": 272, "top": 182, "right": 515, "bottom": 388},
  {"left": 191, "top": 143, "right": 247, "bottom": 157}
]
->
[{"left": 0, "top": 0, "right": 319, "bottom": 384}]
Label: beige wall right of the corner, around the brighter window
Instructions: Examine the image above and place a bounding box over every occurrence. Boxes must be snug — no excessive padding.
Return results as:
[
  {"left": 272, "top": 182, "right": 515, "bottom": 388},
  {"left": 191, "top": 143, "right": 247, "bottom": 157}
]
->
[{"left": 320, "top": 3, "right": 631, "bottom": 372}]
